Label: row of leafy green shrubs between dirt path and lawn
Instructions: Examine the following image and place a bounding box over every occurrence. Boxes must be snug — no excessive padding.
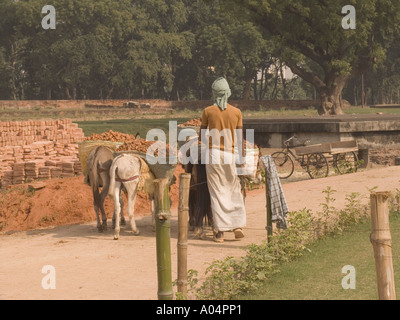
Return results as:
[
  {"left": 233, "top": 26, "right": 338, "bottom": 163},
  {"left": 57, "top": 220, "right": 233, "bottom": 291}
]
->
[{"left": 184, "top": 187, "right": 372, "bottom": 300}]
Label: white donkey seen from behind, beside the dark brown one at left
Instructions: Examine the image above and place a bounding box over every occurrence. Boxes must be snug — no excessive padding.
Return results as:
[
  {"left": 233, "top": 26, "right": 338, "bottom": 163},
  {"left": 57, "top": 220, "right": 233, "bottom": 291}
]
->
[{"left": 109, "top": 153, "right": 154, "bottom": 240}]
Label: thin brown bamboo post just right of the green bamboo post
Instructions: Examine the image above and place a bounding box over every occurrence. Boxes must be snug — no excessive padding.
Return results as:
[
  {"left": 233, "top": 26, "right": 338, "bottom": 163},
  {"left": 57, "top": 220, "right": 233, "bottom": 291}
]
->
[{"left": 177, "top": 173, "right": 191, "bottom": 298}]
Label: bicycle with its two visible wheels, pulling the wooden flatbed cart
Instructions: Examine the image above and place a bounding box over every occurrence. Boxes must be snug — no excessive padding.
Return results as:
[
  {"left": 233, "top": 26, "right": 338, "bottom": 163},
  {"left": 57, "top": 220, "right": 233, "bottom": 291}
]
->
[{"left": 271, "top": 135, "right": 329, "bottom": 179}]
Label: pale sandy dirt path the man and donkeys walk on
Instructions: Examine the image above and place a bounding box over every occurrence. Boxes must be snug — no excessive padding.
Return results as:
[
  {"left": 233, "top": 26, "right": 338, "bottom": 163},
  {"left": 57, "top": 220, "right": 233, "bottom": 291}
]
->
[{"left": 0, "top": 167, "right": 400, "bottom": 299}]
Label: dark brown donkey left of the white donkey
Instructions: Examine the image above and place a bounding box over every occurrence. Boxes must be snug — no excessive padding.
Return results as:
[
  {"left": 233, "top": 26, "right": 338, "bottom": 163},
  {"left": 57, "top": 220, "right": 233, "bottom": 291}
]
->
[{"left": 85, "top": 146, "right": 125, "bottom": 232}]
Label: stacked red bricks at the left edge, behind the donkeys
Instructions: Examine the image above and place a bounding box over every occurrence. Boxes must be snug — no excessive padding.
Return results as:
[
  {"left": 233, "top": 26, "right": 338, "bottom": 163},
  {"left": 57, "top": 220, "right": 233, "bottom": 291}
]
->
[{"left": 0, "top": 119, "right": 84, "bottom": 187}]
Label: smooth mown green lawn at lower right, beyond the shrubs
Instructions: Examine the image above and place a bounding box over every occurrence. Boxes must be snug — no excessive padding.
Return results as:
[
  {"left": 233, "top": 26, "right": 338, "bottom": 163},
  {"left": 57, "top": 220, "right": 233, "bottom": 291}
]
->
[{"left": 244, "top": 213, "right": 400, "bottom": 300}]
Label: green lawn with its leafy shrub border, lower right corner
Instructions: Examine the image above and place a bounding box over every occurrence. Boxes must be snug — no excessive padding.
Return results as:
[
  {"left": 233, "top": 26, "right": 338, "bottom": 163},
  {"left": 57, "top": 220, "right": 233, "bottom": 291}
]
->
[{"left": 187, "top": 187, "right": 400, "bottom": 300}]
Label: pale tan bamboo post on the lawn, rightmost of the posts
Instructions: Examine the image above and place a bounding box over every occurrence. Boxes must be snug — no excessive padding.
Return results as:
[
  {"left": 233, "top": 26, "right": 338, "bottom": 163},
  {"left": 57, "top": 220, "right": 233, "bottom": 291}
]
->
[{"left": 370, "top": 192, "right": 396, "bottom": 300}]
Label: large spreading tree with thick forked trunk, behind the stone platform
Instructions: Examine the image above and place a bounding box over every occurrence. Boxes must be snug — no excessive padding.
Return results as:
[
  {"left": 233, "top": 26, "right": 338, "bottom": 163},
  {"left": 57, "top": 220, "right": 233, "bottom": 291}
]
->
[{"left": 222, "top": 0, "right": 400, "bottom": 114}]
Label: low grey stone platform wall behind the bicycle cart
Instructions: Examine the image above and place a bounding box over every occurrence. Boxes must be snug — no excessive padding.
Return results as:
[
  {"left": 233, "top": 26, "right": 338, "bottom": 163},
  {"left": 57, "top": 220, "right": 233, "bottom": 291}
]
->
[{"left": 243, "top": 115, "right": 400, "bottom": 148}]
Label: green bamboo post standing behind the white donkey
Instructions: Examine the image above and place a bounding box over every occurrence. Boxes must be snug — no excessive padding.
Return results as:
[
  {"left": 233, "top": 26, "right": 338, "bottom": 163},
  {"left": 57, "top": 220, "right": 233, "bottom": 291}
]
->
[{"left": 154, "top": 179, "right": 173, "bottom": 300}]
